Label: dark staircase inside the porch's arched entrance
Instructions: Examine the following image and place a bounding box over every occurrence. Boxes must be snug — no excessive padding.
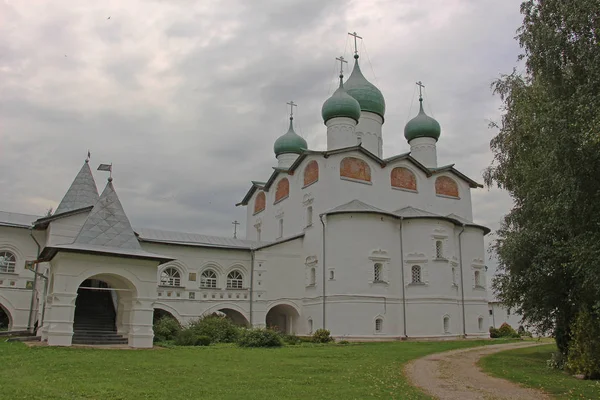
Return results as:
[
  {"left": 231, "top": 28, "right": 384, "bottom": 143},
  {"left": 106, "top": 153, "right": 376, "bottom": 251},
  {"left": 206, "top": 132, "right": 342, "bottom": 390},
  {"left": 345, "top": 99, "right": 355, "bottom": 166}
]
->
[{"left": 72, "top": 289, "right": 127, "bottom": 345}]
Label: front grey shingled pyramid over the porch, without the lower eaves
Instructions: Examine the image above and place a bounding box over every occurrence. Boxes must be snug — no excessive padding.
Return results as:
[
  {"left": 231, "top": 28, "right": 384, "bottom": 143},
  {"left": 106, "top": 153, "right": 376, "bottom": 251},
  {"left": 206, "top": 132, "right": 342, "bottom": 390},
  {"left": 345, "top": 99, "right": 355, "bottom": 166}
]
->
[{"left": 73, "top": 178, "right": 142, "bottom": 250}]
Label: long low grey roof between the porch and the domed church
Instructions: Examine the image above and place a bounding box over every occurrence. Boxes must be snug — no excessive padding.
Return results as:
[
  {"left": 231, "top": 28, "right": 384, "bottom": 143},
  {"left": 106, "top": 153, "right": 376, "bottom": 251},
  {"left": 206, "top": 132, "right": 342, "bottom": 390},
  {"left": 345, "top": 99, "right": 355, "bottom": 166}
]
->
[{"left": 135, "top": 228, "right": 266, "bottom": 250}]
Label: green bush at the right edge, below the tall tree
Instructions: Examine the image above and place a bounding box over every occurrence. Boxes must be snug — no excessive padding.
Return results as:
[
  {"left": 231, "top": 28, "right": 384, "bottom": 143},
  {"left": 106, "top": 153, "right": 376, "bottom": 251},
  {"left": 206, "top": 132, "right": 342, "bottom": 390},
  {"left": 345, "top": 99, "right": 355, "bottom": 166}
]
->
[{"left": 566, "top": 309, "right": 600, "bottom": 379}]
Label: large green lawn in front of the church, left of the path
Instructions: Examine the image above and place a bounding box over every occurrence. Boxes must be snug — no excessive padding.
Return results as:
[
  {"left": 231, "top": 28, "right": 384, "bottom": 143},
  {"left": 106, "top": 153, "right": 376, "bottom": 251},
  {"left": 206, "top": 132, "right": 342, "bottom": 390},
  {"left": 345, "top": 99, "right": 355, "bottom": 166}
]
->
[{"left": 0, "top": 340, "right": 497, "bottom": 400}]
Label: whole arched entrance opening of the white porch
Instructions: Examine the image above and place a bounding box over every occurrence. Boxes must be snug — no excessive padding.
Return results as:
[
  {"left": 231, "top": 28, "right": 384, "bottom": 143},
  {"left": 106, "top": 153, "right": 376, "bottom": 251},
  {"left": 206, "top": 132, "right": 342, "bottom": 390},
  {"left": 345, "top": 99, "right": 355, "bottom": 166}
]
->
[{"left": 72, "top": 275, "right": 136, "bottom": 344}]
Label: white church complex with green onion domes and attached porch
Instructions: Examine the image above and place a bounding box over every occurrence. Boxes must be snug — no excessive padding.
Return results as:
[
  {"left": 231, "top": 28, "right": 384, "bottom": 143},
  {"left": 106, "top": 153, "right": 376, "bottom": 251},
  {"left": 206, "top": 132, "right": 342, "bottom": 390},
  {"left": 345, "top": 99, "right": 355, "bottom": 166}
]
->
[{"left": 0, "top": 47, "right": 506, "bottom": 348}]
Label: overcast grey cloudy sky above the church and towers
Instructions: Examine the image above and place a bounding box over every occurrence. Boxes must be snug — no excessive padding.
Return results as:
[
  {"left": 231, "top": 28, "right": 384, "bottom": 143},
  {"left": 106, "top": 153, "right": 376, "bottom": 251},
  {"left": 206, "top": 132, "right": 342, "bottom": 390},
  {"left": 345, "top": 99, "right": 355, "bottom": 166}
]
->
[{"left": 0, "top": 0, "right": 521, "bottom": 272}]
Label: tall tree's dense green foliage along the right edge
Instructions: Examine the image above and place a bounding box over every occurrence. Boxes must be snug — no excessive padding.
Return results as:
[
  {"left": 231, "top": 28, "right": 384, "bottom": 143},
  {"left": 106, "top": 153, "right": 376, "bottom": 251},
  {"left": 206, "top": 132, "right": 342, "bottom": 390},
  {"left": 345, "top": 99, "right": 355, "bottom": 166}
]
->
[{"left": 484, "top": 0, "right": 600, "bottom": 354}]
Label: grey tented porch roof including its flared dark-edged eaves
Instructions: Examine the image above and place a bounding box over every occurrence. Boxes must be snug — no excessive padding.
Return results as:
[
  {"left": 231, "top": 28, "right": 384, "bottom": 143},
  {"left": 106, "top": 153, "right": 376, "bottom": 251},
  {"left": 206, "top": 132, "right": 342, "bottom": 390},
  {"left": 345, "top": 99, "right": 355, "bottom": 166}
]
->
[{"left": 40, "top": 178, "right": 173, "bottom": 262}]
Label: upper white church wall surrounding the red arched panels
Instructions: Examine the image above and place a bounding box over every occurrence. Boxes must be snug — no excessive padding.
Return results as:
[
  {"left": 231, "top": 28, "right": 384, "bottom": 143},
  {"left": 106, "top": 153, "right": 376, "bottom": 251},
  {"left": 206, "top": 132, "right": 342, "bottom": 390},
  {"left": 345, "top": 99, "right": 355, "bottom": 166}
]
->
[{"left": 246, "top": 152, "right": 473, "bottom": 241}]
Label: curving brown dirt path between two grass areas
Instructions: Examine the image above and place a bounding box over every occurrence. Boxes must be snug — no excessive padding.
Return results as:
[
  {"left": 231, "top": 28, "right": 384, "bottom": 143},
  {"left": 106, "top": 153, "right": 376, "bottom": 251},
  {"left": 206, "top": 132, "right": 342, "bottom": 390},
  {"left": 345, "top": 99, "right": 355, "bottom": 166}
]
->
[{"left": 404, "top": 343, "right": 551, "bottom": 400}]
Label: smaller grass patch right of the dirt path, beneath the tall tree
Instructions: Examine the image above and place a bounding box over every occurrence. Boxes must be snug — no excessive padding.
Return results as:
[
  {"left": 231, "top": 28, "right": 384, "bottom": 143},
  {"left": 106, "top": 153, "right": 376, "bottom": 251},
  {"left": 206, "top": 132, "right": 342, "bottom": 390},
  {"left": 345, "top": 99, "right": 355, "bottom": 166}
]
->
[{"left": 479, "top": 344, "right": 600, "bottom": 400}]
